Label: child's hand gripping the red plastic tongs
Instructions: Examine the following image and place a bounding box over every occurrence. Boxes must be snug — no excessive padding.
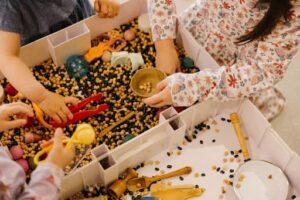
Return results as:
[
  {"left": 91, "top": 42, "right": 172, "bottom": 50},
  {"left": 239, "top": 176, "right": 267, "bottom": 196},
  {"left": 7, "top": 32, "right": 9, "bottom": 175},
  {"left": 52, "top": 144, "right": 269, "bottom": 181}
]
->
[{"left": 38, "top": 91, "right": 78, "bottom": 123}]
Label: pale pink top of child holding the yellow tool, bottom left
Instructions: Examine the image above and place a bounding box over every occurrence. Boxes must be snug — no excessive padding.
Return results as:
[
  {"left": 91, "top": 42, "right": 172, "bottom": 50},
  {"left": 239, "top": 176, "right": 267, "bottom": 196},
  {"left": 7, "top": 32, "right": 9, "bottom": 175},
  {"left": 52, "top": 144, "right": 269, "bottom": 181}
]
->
[{"left": 0, "top": 147, "right": 64, "bottom": 200}]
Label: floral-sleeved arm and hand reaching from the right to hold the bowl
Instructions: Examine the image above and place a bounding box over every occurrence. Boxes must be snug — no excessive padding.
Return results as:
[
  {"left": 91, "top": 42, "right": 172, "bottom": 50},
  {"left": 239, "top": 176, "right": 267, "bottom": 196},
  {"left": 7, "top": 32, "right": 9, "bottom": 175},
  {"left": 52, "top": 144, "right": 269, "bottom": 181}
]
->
[{"left": 144, "top": 13, "right": 300, "bottom": 107}]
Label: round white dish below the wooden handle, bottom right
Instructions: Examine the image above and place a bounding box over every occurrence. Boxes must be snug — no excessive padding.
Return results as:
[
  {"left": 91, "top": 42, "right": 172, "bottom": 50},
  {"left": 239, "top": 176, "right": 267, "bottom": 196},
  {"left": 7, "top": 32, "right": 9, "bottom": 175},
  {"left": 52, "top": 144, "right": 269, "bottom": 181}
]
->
[{"left": 233, "top": 160, "right": 289, "bottom": 200}]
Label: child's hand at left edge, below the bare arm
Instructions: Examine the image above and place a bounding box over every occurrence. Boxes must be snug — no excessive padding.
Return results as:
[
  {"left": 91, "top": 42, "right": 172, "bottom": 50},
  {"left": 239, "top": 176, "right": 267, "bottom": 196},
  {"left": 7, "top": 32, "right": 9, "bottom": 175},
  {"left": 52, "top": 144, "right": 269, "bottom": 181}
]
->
[{"left": 0, "top": 102, "right": 33, "bottom": 131}]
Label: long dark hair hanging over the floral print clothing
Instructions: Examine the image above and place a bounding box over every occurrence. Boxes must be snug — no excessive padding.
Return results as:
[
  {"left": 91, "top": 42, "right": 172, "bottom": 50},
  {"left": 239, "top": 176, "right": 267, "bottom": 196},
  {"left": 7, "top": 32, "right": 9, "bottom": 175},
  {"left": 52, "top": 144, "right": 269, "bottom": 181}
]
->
[{"left": 237, "top": 0, "right": 292, "bottom": 44}]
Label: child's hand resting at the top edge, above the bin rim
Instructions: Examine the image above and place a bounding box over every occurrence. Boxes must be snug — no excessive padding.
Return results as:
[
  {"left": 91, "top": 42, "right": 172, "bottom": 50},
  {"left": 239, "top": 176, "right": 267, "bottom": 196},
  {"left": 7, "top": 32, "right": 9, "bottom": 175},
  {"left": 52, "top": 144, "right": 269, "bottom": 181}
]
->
[{"left": 94, "top": 0, "right": 120, "bottom": 18}]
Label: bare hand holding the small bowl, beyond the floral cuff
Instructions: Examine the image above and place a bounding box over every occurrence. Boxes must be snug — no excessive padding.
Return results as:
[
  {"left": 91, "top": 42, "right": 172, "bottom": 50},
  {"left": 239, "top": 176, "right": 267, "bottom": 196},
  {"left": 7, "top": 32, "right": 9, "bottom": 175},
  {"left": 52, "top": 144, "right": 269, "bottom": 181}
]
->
[{"left": 143, "top": 79, "right": 172, "bottom": 108}]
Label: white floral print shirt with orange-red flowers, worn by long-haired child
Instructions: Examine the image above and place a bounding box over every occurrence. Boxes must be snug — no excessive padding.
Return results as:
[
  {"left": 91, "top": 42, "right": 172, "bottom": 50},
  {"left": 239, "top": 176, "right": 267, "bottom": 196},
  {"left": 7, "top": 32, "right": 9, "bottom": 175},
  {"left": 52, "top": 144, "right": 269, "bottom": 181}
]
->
[{"left": 148, "top": 0, "right": 300, "bottom": 106}]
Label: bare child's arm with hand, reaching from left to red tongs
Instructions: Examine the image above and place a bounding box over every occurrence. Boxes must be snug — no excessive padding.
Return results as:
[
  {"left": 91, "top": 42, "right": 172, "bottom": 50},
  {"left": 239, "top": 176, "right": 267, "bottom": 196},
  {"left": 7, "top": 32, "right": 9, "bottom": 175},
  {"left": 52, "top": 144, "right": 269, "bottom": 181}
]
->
[{"left": 0, "top": 31, "right": 76, "bottom": 123}]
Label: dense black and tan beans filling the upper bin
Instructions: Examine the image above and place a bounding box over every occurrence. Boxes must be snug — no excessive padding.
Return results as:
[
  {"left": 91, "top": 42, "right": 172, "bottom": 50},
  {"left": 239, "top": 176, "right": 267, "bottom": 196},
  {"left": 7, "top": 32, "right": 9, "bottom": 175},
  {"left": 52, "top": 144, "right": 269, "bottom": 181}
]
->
[{"left": 0, "top": 19, "right": 198, "bottom": 198}]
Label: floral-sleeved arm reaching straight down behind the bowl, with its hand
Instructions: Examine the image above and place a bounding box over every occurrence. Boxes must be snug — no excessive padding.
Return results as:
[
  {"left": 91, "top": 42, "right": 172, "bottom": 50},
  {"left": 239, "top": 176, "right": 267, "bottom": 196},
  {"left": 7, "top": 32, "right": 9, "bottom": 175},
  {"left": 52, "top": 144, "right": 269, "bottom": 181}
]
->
[{"left": 148, "top": 0, "right": 180, "bottom": 74}]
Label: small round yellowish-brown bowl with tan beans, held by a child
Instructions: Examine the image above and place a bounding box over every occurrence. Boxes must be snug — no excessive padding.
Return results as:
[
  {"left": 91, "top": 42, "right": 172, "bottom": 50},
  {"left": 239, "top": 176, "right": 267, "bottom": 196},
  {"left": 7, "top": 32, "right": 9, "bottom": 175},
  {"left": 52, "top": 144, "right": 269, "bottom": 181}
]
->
[{"left": 130, "top": 68, "right": 167, "bottom": 97}]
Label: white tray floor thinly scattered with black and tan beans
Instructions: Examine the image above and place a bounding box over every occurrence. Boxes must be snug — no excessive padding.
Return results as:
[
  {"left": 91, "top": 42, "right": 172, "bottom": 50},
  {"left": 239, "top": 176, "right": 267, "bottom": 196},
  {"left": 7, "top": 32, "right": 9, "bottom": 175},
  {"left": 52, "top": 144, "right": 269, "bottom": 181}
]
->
[{"left": 70, "top": 112, "right": 297, "bottom": 200}]
